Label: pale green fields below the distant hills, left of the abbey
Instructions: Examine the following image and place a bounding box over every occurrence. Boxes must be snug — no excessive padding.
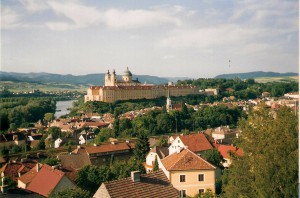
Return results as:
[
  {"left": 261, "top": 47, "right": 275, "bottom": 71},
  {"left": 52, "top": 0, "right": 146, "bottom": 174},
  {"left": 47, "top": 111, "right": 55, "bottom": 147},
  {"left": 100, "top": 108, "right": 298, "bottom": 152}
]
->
[{"left": 0, "top": 81, "right": 88, "bottom": 92}]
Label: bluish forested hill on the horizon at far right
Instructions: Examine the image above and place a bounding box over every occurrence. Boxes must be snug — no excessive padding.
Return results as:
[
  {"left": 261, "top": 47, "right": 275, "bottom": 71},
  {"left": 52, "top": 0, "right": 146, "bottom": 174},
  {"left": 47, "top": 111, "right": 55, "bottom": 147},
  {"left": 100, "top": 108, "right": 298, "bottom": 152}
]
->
[{"left": 215, "top": 71, "right": 298, "bottom": 79}]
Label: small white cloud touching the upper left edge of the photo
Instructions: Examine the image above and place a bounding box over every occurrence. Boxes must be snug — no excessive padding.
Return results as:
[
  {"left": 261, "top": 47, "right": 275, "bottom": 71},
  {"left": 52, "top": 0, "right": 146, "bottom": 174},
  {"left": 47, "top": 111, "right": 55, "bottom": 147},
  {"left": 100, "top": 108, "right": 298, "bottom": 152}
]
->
[{"left": 1, "top": 7, "right": 21, "bottom": 29}]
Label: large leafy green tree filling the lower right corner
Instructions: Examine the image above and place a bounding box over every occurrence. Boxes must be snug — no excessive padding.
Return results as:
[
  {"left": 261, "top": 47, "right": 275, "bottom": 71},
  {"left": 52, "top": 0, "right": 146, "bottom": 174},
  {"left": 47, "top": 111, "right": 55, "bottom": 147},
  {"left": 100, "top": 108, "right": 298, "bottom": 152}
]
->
[{"left": 223, "top": 106, "right": 298, "bottom": 197}]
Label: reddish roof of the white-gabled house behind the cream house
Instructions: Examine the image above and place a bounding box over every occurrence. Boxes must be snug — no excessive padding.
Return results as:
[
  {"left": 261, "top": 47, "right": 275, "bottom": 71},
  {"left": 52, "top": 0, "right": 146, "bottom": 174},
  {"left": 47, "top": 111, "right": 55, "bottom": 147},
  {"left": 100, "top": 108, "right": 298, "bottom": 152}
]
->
[{"left": 179, "top": 133, "right": 213, "bottom": 153}]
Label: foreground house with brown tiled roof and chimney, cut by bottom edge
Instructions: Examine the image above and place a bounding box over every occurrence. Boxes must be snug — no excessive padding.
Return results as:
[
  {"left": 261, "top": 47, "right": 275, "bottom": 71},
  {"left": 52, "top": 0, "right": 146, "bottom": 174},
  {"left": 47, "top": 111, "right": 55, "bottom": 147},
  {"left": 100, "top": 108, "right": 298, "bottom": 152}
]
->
[{"left": 93, "top": 171, "right": 178, "bottom": 198}]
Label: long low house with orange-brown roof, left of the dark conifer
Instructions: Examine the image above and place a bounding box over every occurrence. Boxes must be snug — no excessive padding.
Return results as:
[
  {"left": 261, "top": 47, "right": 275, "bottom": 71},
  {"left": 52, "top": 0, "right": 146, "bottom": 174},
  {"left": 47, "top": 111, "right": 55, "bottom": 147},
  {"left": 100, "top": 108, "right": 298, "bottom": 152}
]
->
[{"left": 85, "top": 141, "right": 134, "bottom": 165}]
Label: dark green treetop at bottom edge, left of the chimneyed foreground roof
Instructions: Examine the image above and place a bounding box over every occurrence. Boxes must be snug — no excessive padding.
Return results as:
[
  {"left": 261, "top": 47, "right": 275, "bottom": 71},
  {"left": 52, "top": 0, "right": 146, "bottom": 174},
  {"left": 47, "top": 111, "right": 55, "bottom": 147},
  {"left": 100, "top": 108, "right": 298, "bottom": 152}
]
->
[{"left": 49, "top": 187, "right": 91, "bottom": 198}]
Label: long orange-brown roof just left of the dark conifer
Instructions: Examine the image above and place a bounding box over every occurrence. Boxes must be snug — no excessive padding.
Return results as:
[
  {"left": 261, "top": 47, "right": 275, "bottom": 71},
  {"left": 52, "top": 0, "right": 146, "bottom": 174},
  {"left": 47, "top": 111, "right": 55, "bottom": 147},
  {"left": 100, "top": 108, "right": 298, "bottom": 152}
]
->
[{"left": 85, "top": 142, "right": 130, "bottom": 154}]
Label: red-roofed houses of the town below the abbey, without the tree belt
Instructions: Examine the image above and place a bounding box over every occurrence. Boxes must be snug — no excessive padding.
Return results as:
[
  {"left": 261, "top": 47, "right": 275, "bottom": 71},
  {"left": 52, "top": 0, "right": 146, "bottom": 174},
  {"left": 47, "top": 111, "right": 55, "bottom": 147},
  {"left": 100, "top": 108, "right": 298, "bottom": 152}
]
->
[{"left": 0, "top": 88, "right": 299, "bottom": 197}]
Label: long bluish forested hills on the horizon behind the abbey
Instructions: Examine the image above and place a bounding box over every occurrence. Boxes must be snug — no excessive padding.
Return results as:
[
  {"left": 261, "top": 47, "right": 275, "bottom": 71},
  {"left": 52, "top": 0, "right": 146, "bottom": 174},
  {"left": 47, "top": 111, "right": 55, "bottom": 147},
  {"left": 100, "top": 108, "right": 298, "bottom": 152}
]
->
[{"left": 0, "top": 72, "right": 187, "bottom": 85}]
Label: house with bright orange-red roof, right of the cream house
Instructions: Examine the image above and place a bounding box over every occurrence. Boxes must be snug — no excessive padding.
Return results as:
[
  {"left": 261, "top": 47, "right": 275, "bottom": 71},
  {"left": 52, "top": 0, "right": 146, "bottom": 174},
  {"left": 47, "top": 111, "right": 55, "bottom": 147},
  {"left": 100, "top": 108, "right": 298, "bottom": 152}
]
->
[{"left": 215, "top": 144, "right": 243, "bottom": 168}]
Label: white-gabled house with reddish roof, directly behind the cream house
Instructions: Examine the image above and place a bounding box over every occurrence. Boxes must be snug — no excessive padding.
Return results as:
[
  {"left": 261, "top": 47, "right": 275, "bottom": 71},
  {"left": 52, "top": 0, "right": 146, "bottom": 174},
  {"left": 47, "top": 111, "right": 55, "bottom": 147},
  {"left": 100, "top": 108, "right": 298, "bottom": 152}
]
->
[{"left": 169, "top": 133, "right": 213, "bottom": 155}]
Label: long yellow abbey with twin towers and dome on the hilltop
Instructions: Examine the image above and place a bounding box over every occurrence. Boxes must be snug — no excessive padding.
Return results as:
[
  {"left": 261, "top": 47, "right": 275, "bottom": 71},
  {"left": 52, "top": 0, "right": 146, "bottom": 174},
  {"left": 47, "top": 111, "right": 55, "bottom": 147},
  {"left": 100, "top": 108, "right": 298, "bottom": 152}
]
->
[{"left": 84, "top": 67, "right": 199, "bottom": 103}]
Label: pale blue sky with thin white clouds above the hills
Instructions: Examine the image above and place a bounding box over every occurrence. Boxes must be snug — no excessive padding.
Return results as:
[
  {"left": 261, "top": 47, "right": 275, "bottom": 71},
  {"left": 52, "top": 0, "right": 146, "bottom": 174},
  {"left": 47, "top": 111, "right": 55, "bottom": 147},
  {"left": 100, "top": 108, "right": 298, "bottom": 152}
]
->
[{"left": 0, "top": 0, "right": 299, "bottom": 78}]
